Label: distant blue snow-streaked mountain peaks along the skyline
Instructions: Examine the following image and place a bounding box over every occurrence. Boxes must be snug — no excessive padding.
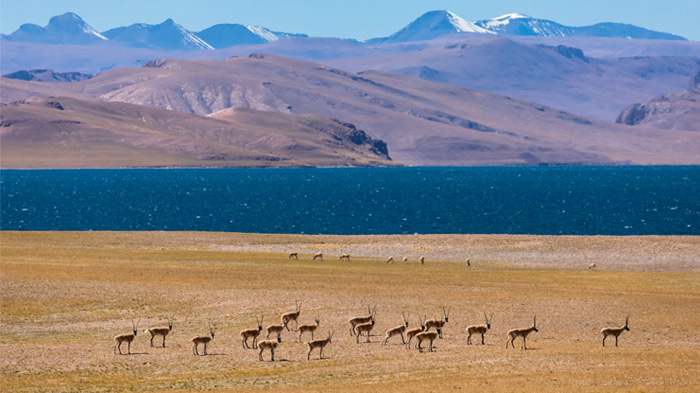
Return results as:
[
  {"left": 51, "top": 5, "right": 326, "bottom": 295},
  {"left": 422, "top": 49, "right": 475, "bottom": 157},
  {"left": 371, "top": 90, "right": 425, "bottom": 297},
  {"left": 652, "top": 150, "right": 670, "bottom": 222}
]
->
[{"left": 2, "top": 11, "right": 685, "bottom": 50}]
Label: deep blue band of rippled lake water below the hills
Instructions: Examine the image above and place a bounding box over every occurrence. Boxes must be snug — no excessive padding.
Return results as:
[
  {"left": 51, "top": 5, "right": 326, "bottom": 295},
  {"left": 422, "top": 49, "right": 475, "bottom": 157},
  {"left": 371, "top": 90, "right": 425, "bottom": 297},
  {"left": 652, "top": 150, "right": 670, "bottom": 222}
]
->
[{"left": 0, "top": 166, "right": 700, "bottom": 235}]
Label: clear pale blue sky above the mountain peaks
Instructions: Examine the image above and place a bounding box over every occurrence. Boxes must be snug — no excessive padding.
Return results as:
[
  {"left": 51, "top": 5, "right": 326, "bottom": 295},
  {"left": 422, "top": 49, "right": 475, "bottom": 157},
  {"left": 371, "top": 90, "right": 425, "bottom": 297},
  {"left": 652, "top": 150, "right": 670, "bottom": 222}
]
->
[{"left": 0, "top": 0, "right": 700, "bottom": 41}]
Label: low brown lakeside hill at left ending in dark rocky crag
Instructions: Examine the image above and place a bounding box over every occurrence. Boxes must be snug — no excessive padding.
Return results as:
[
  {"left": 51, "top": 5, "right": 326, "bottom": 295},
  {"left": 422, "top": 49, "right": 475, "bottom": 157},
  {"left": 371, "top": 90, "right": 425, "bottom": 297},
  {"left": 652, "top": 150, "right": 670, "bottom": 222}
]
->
[{"left": 0, "top": 97, "right": 396, "bottom": 168}]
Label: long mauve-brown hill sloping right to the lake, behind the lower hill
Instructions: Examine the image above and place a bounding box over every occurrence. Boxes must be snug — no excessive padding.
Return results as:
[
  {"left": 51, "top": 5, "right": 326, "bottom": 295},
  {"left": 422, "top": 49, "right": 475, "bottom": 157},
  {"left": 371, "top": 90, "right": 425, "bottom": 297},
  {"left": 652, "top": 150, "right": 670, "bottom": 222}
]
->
[{"left": 1, "top": 54, "right": 700, "bottom": 165}]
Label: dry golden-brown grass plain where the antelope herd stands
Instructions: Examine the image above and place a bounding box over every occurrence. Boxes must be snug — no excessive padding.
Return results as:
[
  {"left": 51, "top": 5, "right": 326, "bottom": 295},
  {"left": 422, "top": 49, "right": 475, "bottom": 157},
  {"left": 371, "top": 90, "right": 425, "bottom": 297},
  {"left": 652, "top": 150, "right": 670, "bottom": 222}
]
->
[{"left": 0, "top": 232, "right": 700, "bottom": 392}]
